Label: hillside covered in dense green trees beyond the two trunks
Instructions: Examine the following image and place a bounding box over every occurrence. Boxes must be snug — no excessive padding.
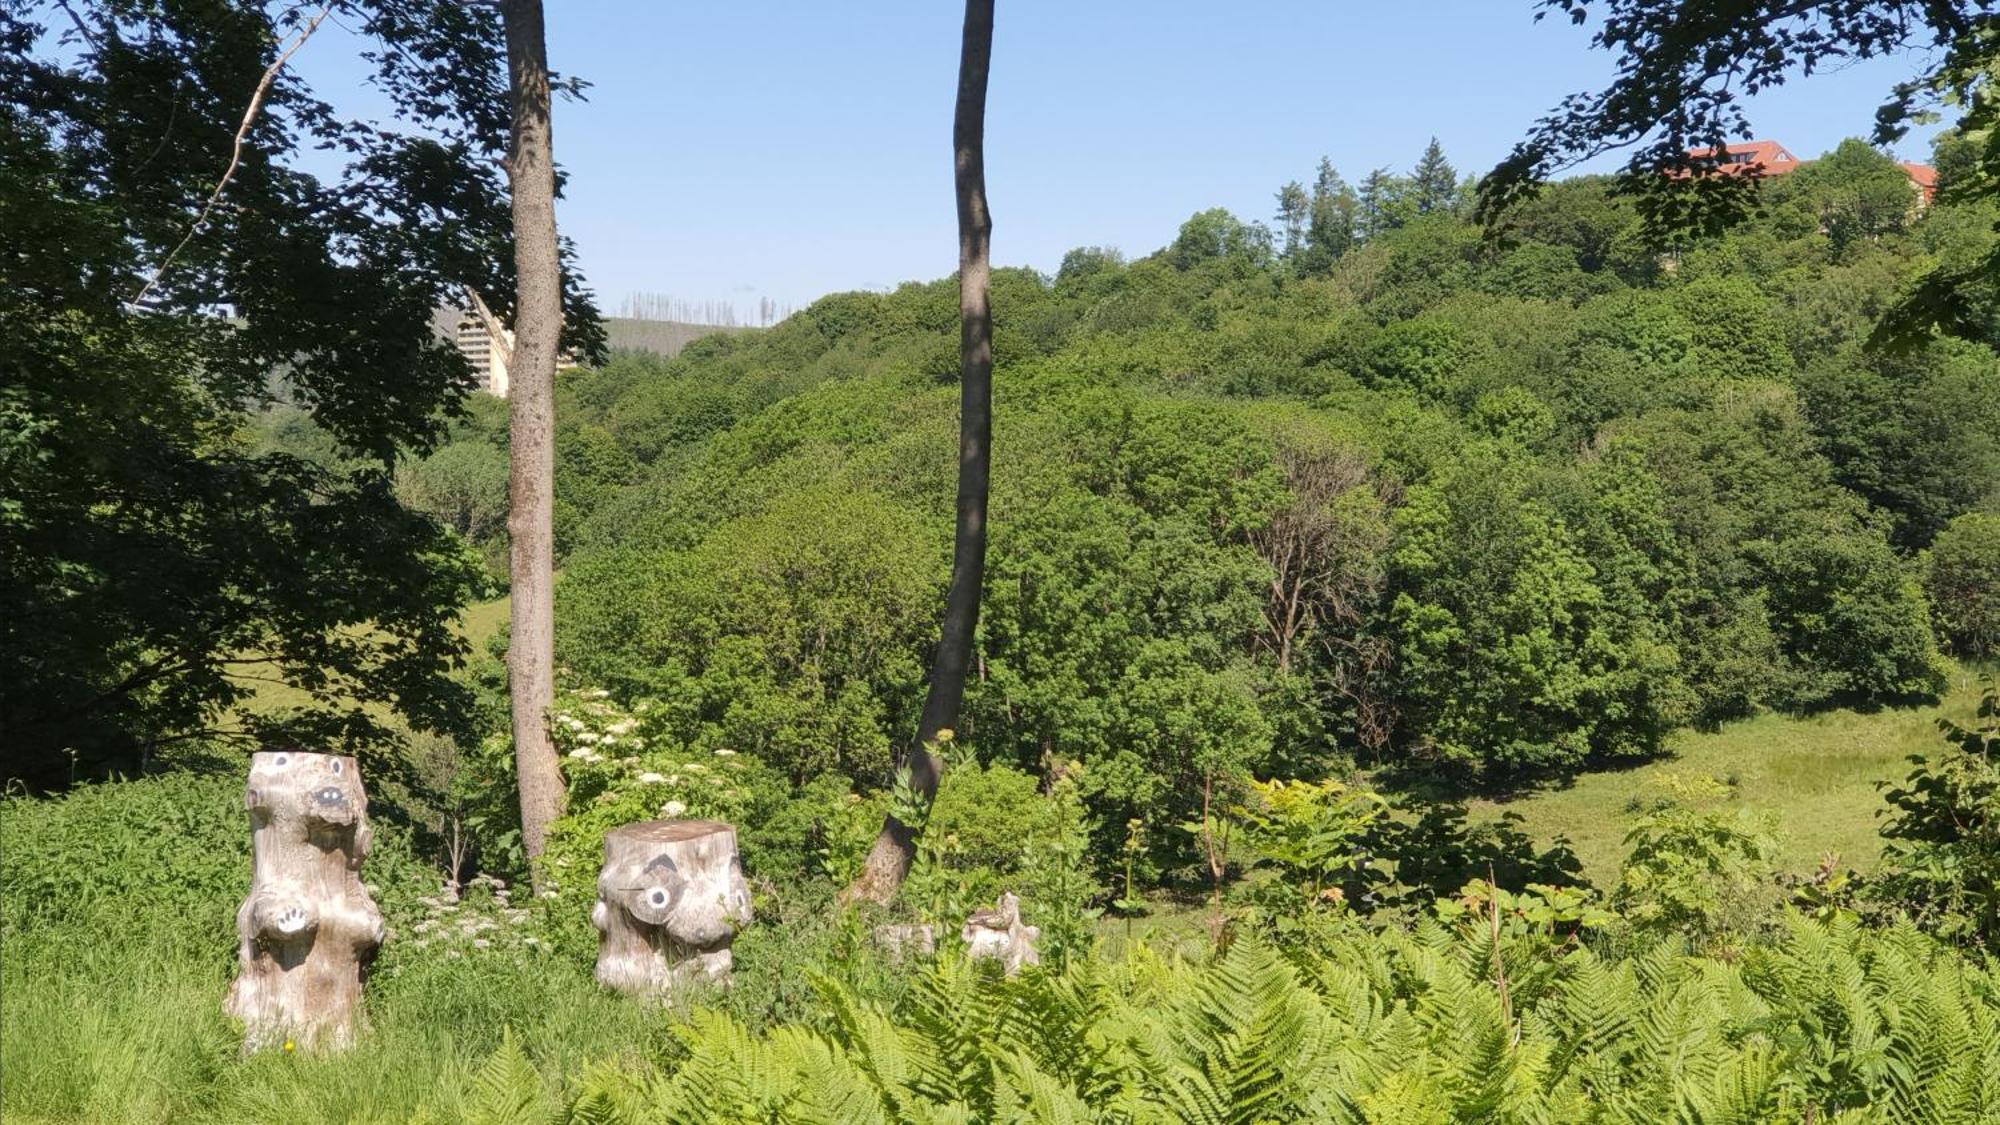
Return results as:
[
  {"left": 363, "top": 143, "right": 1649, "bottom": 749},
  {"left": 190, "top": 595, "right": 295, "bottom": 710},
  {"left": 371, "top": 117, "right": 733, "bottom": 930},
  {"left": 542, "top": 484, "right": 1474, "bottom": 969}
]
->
[{"left": 404, "top": 142, "right": 2000, "bottom": 825}]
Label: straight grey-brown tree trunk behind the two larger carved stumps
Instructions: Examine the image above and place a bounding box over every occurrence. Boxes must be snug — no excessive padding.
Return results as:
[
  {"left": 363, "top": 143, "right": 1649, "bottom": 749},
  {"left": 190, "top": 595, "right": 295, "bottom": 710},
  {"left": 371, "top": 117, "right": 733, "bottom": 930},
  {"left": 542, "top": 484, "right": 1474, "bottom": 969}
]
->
[{"left": 502, "top": 0, "right": 562, "bottom": 861}]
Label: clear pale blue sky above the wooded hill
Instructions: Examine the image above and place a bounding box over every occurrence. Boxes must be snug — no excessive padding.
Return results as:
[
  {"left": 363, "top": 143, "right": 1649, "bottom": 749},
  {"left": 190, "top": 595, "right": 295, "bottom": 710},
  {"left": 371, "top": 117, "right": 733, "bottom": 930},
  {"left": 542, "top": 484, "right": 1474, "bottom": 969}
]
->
[{"left": 320, "top": 0, "right": 1928, "bottom": 312}]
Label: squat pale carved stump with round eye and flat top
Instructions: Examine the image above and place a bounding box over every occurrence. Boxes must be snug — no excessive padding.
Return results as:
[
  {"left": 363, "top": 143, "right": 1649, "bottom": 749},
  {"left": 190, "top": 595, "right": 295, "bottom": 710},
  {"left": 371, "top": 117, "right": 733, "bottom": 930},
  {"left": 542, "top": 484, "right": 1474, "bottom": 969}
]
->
[{"left": 590, "top": 821, "right": 750, "bottom": 995}]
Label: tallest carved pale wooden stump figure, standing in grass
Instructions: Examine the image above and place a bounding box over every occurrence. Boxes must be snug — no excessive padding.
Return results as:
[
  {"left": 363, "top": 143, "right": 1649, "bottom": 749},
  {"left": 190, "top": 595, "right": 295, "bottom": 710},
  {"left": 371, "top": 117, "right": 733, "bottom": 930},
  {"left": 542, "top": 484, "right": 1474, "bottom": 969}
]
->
[{"left": 222, "top": 751, "right": 382, "bottom": 1051}]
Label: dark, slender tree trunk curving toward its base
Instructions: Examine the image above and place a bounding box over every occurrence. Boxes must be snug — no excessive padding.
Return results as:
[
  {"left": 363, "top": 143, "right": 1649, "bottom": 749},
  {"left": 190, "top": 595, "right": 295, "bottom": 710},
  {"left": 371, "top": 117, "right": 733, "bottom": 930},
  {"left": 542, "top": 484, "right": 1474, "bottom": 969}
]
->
[{"left": 842, "top": 0, "right": 994, "bottom": 903}]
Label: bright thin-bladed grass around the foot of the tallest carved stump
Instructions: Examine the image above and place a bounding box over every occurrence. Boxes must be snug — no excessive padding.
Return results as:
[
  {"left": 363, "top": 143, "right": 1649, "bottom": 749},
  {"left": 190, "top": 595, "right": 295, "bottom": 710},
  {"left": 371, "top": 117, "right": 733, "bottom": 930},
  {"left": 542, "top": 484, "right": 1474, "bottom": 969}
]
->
[{"left": 0, "top": 927, "right": 670, "bottom": 1123}]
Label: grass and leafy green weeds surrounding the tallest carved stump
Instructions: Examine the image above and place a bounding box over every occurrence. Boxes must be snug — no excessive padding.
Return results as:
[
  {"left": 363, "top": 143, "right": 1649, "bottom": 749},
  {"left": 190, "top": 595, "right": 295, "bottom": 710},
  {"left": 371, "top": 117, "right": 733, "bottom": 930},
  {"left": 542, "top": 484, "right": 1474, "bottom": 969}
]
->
[{"left": 0, "top": 777, "right": 670, "bottom": 1125}]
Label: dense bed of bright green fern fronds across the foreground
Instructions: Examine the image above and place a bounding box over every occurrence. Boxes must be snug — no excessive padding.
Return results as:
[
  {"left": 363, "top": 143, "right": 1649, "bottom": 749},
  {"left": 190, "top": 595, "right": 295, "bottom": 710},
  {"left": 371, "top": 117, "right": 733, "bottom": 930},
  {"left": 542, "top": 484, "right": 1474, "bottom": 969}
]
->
[{"left": 528, "top": 919, "right": 2000, "bottom": 1125}]
